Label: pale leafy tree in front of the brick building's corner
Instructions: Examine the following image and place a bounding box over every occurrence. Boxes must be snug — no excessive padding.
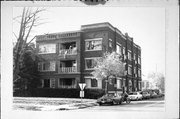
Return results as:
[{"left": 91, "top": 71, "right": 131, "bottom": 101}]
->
[{"left": 91, "top": 52, "right": 125, "bottom": 93}]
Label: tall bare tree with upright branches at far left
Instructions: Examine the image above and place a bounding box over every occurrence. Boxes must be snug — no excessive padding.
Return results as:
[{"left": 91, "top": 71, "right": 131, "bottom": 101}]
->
[{"left": 13, "top": 8, "right": 45, "bottom": 82}]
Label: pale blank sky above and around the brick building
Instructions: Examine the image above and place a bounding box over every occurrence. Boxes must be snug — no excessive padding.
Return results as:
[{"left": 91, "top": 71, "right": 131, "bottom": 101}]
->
[{"left": 13, "top": 7, "right": 165, "bottom": 79}]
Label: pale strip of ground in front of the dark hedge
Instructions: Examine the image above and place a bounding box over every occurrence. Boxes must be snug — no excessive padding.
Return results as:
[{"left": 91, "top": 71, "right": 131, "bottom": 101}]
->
[{"left": 13, "top": 97, "right": 98, "bottom": 111}]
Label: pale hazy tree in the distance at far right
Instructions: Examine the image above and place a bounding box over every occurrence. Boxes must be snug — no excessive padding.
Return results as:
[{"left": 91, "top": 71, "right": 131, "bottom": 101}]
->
[{"left": 148, "top": 72, "right": 165, "bottom": 92}]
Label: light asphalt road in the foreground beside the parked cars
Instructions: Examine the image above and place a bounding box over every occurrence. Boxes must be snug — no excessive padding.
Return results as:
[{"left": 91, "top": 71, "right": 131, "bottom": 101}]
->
[{"left": 73, "top": 97, "right": 165, "bottom": 112}]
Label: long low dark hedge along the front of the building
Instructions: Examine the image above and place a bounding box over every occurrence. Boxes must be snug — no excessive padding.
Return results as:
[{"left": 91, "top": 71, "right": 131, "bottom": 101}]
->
[{"left": 13, "top": 88, "right": 104, "bottom": 99}]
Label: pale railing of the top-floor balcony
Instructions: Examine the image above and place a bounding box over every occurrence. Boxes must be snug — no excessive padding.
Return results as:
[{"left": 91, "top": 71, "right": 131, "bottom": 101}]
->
[{"left": 59, "top": 47, "right": 77, "bottom": 55}]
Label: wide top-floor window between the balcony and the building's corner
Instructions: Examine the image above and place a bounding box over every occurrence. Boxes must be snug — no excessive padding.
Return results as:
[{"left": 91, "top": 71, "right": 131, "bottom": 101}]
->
[{"left": 85, "top": 38, "right": 102, "bottom": 51}]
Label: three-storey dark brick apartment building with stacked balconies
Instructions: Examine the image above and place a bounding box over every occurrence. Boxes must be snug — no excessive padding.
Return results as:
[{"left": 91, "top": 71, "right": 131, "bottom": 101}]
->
[{"left": 36, "top": 22, "right": 141, "bottom": 98}]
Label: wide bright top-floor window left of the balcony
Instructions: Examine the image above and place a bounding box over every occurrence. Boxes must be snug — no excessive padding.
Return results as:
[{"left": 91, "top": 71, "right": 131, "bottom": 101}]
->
[{"left": 39, "top": 44, "right": 56, "bottom": 54}]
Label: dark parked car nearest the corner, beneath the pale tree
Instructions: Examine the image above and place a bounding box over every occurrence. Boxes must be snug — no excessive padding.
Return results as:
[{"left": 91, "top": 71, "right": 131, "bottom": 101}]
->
[{"left": 97, "top": 93, "right": 123, "bottom": 105}]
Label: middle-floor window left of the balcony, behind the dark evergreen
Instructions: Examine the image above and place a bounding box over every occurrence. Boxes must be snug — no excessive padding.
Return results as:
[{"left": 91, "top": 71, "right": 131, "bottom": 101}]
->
[{"left": 38, "top": 61, "right": 56, "bottom": 71}]
